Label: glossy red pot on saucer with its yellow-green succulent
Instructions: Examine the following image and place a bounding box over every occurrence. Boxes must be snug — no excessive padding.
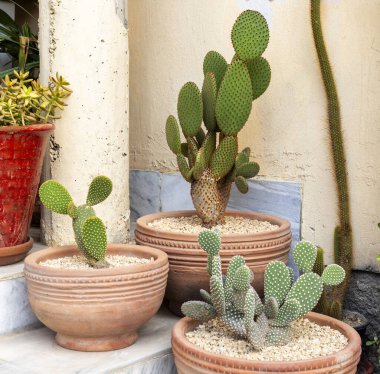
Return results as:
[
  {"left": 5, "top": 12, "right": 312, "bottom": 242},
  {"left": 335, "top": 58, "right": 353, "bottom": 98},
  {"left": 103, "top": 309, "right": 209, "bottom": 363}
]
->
[{"left": 0, "top": 70, "right": 71, "bottom": 265}]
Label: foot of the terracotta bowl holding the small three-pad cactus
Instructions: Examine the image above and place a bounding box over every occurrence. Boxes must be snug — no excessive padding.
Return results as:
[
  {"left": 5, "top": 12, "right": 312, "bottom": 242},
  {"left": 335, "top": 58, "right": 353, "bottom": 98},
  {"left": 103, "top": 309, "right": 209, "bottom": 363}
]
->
[{"left": 55, "top": 332, "right": 138, "bottom": 352}]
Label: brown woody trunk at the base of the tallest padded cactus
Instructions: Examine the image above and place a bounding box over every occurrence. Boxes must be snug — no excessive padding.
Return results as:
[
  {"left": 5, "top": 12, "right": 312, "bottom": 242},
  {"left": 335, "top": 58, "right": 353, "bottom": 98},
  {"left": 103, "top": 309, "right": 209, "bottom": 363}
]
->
[{"left": 191, "top": 169, "right": 232, "bottom": 228}]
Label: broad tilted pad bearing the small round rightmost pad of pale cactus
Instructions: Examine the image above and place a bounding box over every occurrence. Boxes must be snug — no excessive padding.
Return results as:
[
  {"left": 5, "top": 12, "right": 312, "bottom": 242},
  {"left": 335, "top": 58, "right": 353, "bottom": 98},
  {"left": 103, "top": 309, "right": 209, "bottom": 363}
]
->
[{"left": 286, "top": 273, "right": 323, "bottom": 317}]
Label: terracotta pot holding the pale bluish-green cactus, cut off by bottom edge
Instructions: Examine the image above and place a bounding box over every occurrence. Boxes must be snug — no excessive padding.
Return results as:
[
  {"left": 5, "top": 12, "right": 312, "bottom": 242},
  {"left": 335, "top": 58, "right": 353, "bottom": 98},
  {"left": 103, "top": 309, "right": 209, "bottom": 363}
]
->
[{"left": 172, "top": 313, "right": 361, "bottom": 374}]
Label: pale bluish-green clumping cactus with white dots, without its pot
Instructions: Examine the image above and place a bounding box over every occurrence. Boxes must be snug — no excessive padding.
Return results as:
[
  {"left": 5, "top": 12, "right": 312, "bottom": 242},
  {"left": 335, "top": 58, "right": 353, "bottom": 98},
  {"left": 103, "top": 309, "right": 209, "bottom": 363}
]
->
[{"left": 181, "top": 230, "right": 345, "bottom": 350}]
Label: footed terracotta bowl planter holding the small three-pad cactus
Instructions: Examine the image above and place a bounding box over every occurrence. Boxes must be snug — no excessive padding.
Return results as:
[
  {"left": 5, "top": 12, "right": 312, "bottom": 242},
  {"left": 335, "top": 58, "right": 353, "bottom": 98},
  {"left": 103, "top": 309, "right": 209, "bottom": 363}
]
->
[{"left": 24, "top": 244, "right": 169, "bottom": 351}]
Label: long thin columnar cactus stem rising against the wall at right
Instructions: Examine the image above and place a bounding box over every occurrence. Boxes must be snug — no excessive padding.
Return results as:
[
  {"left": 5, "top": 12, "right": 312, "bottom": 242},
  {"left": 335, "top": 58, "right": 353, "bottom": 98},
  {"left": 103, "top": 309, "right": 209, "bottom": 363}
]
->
[{"left": 311, "top": 0, "right": 353, "bottom": 309}]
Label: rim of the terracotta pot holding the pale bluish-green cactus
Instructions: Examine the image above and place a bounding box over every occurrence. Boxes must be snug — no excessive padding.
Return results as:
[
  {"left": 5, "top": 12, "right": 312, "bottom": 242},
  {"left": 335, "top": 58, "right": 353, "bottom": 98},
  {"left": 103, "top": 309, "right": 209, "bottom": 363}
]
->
[{"left": 172, "top": 312, "right": 361, "bottom": 372}]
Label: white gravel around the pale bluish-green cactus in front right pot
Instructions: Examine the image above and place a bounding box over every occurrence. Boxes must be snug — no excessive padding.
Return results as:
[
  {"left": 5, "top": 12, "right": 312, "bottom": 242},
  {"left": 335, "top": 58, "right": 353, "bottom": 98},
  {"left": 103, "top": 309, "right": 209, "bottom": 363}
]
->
[{"left": 186, "top": 318, "right": 348, "bottom": 361}]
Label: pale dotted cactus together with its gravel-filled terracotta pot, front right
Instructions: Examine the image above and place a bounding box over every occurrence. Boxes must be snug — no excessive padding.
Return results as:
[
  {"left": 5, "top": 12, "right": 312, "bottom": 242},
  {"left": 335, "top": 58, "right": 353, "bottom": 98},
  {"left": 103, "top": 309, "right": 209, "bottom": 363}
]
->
[{"left": 172, "top": 231, "right": 361, "bottom": 374}]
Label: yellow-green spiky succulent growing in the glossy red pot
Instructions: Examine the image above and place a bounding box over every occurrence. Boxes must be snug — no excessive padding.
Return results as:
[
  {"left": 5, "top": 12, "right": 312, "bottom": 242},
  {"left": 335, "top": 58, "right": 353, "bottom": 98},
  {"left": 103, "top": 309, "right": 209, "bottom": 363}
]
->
[{"left": 0, "top": 70, "right": 72, "bottom": 126}]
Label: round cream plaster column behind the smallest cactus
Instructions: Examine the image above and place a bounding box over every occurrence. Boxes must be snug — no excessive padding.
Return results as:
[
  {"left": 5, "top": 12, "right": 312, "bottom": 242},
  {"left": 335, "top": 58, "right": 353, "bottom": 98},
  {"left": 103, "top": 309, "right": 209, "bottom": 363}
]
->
[{"left": 39, "top": 0, "right": 129, "bottom": 245}]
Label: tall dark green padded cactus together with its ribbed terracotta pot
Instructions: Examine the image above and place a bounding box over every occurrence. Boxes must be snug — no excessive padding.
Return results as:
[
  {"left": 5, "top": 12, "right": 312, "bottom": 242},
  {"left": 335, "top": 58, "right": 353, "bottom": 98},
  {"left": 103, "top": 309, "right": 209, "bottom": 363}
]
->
[{"left": 135, "top": 10, "right": 291, "bottom": 314}]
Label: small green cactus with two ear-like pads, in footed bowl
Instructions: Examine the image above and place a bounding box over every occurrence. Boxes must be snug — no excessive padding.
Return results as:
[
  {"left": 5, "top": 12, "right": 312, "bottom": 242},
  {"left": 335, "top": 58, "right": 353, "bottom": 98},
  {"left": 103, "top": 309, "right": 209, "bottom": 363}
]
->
[{"left": 39, "top": 176, "right": 112, "bottom": 268}]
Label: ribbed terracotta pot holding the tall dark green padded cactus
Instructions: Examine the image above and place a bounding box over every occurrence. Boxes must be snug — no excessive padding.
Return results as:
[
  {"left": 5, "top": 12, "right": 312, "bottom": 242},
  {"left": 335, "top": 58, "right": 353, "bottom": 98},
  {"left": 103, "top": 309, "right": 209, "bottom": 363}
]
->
[{"left": 135, "top": 211, "right": 291, "bottom": 315}]
